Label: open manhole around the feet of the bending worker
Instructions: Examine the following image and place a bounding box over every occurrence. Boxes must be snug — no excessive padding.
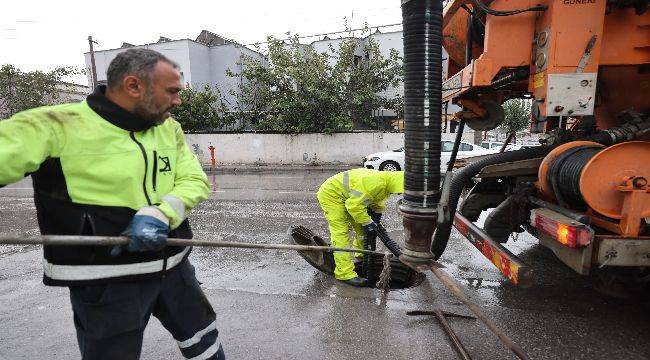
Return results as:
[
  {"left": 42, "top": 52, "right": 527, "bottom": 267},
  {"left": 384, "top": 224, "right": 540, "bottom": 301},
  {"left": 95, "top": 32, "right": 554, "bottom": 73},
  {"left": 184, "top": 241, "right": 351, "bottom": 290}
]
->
[{"left": 289, "top": 226, "right": 425, "bottom": 289}]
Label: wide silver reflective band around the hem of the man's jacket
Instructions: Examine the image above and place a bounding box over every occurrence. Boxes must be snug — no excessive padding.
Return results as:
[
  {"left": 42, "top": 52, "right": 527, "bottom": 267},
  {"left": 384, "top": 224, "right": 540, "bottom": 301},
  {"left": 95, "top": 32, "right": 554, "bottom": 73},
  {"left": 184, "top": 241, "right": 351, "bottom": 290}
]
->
[{"left": 43, "top": 247, "right": 190, "bottom": 281}]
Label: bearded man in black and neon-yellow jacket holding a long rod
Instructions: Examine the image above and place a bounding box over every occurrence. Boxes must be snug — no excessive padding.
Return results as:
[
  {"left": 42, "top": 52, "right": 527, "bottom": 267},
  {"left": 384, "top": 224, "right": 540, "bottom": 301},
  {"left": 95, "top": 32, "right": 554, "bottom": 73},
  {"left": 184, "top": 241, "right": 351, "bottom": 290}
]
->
[{"left": 0, "top": 49, "right": 225, "bottom": 359}]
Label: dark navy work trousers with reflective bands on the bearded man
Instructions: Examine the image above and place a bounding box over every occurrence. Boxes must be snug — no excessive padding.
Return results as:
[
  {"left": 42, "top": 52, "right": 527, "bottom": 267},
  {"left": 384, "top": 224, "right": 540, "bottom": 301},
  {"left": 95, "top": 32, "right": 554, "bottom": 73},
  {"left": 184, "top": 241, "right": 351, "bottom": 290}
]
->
[{"left": 70, "top": 260, "right": 225, "bottom": 360}]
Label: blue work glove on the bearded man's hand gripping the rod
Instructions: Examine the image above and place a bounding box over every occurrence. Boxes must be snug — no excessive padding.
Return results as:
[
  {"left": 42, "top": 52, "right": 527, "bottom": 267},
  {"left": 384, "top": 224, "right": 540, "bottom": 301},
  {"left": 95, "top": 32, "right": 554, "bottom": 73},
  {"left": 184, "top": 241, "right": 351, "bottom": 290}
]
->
[{"left": 111, "top": 206, "right": 169, "bottom": 256}]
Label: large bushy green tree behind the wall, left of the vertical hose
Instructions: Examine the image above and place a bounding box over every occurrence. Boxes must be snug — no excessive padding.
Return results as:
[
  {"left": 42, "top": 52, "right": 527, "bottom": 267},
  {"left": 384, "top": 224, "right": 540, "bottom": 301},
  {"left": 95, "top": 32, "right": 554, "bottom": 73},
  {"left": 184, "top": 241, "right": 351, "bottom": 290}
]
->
[{"left": 228, "top": 29, "right": 403, "bottom": 133}]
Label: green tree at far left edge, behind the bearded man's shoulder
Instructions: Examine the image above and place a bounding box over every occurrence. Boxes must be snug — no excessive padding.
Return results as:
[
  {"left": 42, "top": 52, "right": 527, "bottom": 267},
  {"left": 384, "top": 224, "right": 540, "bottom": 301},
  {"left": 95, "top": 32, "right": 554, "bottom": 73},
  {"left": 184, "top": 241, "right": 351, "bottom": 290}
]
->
[{"left": 0, "top": 64, "right": 82, "bottom": 119}]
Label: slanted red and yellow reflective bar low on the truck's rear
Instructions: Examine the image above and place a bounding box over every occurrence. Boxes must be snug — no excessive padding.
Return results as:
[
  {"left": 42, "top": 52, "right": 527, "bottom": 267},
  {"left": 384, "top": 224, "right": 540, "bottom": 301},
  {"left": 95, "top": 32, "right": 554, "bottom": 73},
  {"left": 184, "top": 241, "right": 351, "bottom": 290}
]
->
[{"left": 454, "top": 213, "right": 532, "bottom": 288}]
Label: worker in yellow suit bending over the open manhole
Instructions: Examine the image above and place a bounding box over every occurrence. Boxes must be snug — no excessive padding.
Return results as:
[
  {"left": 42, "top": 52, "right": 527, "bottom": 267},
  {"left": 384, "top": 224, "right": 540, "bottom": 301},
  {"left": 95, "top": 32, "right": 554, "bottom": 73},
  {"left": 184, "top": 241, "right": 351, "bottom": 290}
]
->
[{"left": 317, "top": 169, "right": 404, "bottom": 286}]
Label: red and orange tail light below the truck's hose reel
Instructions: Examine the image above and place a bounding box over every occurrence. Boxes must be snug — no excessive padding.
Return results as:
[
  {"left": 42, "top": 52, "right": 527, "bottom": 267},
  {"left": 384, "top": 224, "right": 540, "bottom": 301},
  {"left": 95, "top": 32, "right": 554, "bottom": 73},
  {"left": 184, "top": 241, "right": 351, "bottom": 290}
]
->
[{"left": 530, "top": 208, "right": 594, "bottom": 248}]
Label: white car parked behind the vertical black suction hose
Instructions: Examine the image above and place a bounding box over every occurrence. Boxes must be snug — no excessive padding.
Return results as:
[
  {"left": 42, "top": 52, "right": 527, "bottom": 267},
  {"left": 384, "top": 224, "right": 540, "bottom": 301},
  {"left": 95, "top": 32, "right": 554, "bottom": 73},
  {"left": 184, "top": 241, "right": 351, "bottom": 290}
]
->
[{"left": 363, "top": 140, "right": 498, "bottom": 173}]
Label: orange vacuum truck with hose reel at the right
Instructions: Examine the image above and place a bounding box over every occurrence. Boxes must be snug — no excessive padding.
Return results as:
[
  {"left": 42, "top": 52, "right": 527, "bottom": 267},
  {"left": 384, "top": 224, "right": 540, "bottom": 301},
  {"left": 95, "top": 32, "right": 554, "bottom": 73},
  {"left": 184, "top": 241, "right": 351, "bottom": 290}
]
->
[{"left": 422, "top": 0, "right": 650, "bottom": 289}]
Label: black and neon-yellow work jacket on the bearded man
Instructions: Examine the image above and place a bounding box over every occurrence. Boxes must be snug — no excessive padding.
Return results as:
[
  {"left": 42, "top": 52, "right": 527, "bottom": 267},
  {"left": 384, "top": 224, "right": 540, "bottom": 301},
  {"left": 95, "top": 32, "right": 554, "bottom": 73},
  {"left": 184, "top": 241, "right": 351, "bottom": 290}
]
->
[{"left": 0, "top": 88, "right": 210, "bottom": 285}]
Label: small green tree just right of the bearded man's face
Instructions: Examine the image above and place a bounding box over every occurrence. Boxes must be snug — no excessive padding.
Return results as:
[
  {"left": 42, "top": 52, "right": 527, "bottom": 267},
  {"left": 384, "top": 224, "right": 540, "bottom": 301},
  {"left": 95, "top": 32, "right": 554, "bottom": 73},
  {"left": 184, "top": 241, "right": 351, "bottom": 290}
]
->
[{"left": 172, "top": 85, "right": 235, "bottom": 132}]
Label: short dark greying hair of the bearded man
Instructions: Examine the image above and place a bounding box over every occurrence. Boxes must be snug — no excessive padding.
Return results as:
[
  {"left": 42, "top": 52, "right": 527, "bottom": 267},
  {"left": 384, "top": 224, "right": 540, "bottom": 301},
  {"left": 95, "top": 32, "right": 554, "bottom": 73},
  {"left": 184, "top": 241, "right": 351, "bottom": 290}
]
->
[{"left": 106, "top": 48, "right": 178, "bottom": 88}]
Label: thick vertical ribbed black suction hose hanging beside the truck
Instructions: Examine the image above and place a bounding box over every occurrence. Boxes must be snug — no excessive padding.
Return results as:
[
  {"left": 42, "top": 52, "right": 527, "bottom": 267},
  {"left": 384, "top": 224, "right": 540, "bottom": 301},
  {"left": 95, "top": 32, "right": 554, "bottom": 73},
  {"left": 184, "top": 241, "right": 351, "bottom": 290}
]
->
[{"left": 402, "top": 0, "right": 442, "bottom": 209}]
